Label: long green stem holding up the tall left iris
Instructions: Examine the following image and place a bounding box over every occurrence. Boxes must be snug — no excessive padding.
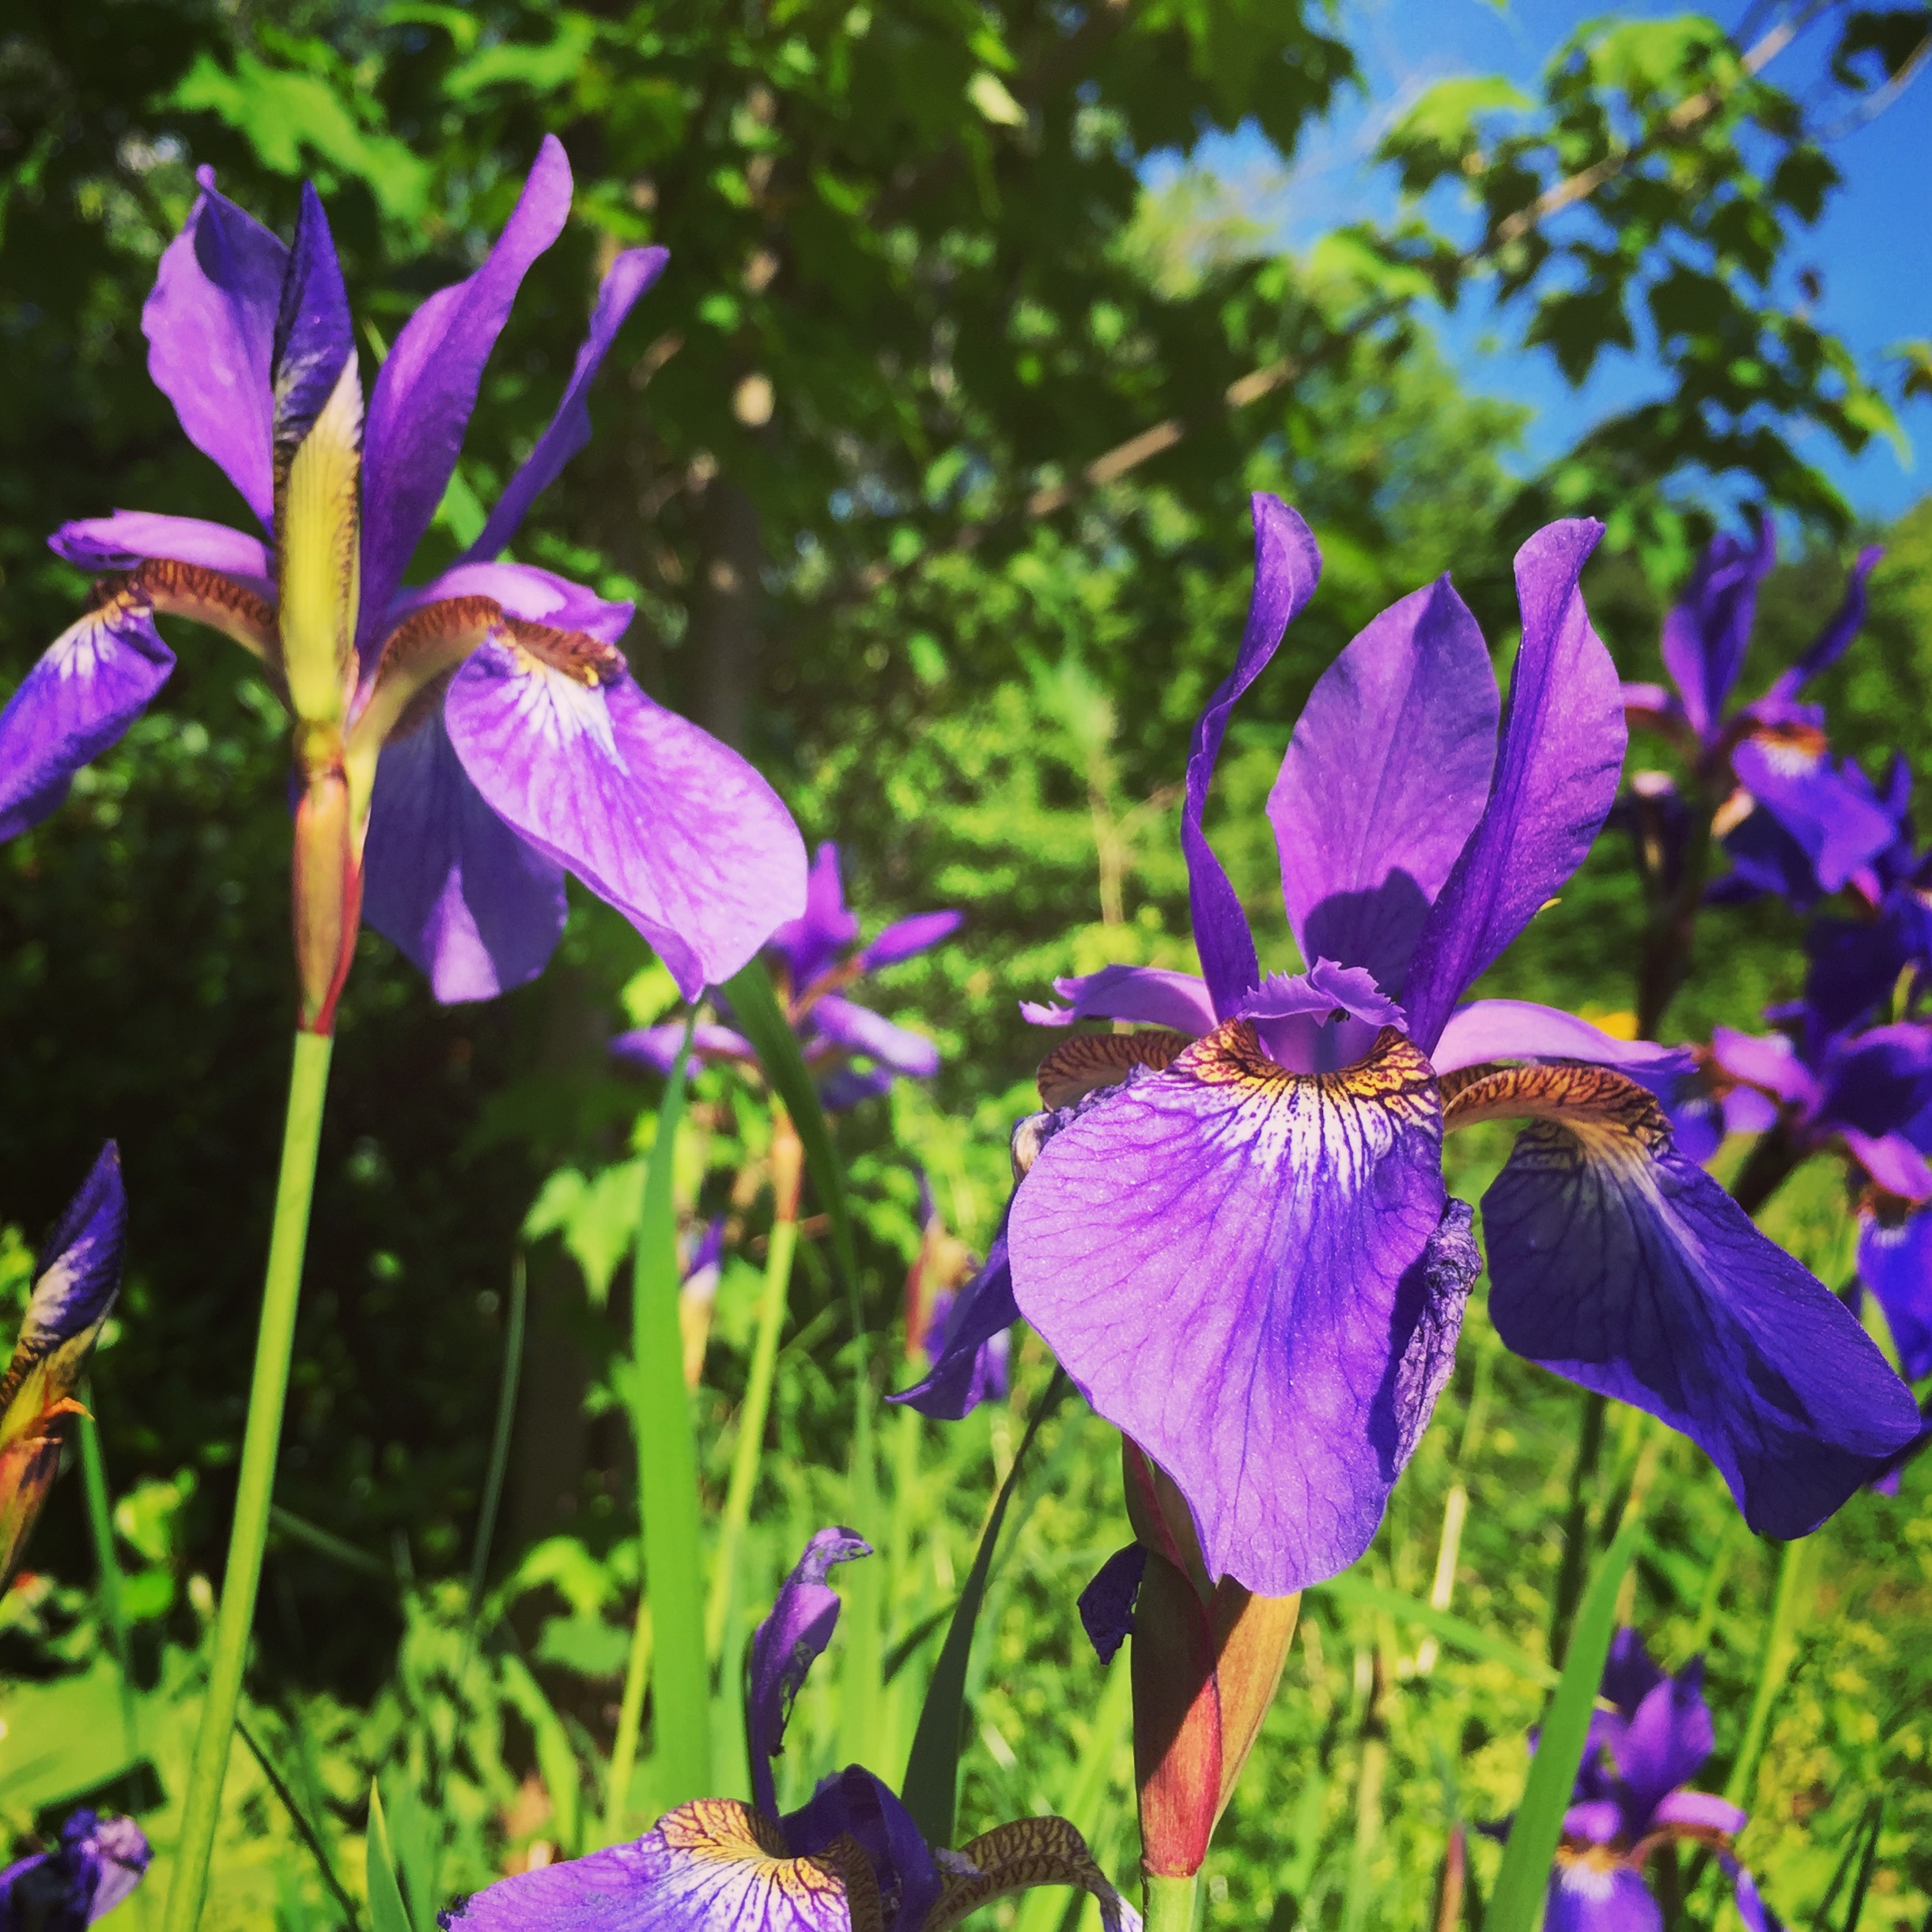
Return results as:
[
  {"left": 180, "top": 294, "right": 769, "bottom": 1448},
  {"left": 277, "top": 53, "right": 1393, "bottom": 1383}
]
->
[{"left": 162, "top": 1032, "right": 335, "bottom": 1932}]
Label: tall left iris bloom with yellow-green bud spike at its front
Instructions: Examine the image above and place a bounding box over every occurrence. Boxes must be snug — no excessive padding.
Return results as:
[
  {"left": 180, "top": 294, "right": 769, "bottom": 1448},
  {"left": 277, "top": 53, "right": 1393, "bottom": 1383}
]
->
[{"left": 0, "top": 137, "right": 806, "bottom": 1030}]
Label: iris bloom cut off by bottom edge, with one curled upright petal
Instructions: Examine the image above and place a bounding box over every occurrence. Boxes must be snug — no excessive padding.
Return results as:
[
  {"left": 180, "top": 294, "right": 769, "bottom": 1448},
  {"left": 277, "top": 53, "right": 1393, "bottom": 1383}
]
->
[{"left": 439, "top": 1528, "right": 1140, "bottom": 1932}]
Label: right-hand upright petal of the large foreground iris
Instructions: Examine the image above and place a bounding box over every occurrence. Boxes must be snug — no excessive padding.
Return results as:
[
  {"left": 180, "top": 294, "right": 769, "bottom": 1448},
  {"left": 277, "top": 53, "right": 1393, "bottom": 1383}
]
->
[{"left": 1403, "top": 518, "right": 1625, "bottom": 1053}]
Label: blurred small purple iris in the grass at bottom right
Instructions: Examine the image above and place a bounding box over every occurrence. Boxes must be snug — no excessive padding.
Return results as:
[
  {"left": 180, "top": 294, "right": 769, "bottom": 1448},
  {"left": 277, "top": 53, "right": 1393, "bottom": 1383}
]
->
[{"left": 1544, "top": 1631, "right": 1778, "bottom": 1932}]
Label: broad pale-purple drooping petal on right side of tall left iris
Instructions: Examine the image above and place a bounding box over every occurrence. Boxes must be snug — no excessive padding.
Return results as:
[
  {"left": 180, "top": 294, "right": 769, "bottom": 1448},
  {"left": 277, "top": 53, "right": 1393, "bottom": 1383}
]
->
[{"left": 444, "top": 640, "right": 806, "bottom": 999}]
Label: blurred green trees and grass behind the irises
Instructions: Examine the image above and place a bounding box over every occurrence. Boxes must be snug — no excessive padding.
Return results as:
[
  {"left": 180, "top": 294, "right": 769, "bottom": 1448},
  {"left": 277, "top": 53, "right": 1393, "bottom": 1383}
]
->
[{"left": 0, "top": 0, "right": 1932, "bottom": 1932}]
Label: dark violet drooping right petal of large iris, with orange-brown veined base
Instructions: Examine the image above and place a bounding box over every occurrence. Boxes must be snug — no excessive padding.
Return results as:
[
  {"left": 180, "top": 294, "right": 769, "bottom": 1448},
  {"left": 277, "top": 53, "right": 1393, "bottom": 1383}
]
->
[{"left": 1451, "top": 1067, "right": 1919, "bottom": 1536}]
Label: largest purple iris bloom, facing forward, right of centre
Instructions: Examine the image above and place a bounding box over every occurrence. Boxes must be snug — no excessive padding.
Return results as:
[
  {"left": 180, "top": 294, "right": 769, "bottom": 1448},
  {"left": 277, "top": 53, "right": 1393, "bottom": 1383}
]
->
[{"left": 915, "top": 497, "right": 1915, "bottom": 1596}]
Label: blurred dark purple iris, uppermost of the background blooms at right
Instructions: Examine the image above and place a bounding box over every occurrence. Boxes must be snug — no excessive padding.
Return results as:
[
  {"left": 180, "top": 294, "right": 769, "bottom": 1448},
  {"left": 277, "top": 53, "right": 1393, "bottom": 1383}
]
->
[{"left": 1623, "top": 516, "right": 1892, "bottom": 906}]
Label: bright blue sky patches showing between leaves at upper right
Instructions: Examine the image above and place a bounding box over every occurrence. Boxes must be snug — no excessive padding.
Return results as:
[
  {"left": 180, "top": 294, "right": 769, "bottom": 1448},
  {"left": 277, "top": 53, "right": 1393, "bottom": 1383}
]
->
[{"left": 1159, "top": 0, "right": 1932, "bottom": 518}]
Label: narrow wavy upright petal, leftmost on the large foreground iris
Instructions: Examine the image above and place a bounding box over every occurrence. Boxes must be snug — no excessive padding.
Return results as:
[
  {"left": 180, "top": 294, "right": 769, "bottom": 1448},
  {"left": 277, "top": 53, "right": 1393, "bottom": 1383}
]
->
[{"left": 1181, "top": 491, "right": 1321, "bottom": 1018}]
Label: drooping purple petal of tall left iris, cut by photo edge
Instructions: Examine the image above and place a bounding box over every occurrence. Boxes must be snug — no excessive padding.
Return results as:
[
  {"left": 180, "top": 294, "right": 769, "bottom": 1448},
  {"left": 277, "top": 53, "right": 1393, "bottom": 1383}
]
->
[{"left": 0, "top": 597, "right": 174, "bottom": 838}]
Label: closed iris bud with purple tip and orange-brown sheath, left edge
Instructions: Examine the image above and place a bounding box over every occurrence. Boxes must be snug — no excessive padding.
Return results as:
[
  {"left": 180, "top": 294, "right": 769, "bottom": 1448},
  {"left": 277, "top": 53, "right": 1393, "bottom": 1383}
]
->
[{"left": 0, "top": 1140, "right": 127, "bottom": 1584}]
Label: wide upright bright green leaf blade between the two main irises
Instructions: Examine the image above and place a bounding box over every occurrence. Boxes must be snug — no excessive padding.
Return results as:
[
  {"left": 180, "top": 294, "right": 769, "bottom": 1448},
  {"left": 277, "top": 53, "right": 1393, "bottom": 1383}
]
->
[{"left": 605, "top": 1022, "right": 711, "bottom": 1843}]
